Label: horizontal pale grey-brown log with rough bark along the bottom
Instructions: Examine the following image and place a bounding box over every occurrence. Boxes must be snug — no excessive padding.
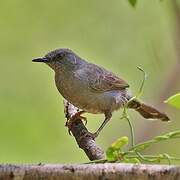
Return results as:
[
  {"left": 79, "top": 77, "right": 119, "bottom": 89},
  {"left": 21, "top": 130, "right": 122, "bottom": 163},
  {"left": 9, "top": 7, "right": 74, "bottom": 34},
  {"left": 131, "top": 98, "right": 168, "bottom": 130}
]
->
[{"left": 0, "top": 163, "right": 180, "bottom": 180}]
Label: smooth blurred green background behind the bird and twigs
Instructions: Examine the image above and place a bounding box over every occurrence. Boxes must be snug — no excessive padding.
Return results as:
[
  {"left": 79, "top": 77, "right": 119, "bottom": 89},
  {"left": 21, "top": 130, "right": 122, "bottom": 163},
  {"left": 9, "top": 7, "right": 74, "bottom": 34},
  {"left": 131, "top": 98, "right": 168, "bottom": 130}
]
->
[{"left": 0, "top": 0, "right": 180, "bottom": 163}]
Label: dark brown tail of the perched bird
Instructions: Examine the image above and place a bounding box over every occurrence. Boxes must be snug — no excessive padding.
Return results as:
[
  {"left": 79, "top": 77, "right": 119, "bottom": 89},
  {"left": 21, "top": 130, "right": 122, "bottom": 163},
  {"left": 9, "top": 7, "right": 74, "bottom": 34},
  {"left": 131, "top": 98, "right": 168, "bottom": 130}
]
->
[{"left": 128, "top": 100, "right": 170, "bottom": 121}]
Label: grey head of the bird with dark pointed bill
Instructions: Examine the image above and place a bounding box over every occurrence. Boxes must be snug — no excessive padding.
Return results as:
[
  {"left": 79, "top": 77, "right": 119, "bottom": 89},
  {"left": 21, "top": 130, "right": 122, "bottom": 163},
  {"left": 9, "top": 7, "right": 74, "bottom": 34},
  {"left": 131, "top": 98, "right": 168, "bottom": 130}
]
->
[{"left": 32, "top": 49, "right": 82, "bottom": 72}]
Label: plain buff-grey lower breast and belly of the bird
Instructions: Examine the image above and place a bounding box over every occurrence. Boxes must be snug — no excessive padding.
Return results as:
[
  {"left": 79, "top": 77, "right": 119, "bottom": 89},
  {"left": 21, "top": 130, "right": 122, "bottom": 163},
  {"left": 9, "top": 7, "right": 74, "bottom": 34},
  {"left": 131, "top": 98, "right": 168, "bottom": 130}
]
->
[{"left": 56, "top": 73, "right": 129, "bottom": 114}]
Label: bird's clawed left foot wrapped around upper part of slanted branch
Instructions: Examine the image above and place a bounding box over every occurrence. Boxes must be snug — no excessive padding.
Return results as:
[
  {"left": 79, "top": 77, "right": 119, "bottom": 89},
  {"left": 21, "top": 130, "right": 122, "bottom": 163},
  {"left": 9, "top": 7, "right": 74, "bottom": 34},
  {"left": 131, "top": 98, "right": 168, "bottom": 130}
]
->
[{"left": 66, "top": 111, "right": 87, "bottom": 135}]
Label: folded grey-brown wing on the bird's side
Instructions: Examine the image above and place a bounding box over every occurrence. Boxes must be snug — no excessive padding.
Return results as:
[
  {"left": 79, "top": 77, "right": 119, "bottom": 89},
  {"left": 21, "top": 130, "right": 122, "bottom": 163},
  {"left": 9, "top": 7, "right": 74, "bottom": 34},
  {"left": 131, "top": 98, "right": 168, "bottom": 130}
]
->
[{"left": 81, "top": 63, "right": 129, "bottom": 92}]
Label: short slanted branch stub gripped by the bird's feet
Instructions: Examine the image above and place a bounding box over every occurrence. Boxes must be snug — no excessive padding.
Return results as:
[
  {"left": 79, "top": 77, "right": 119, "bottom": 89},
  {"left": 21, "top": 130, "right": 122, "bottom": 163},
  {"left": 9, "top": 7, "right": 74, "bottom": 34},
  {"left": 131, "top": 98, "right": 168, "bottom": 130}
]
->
[{"left": 64, "top": 100, "right": 105, "bottom": 160}]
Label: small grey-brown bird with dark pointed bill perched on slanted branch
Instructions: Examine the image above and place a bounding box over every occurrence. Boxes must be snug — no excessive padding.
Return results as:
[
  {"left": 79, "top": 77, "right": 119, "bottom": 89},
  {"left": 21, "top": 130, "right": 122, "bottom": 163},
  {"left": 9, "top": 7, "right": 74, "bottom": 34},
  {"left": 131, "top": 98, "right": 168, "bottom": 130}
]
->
[{"left": 32, "top": 48, "right": 169, "bottom": 138}]
